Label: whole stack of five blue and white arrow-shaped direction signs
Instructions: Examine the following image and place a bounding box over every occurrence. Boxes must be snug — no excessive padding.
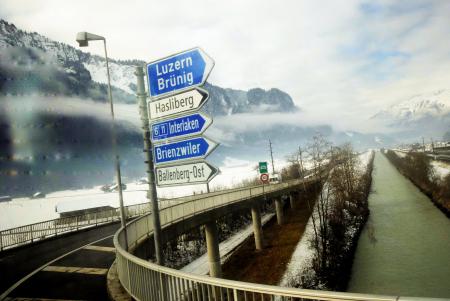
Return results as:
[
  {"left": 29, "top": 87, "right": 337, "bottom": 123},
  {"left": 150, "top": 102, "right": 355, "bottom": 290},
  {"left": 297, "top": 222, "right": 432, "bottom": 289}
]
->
[{"left": 147, "top": 48, "right": 218, "bottom": 186}]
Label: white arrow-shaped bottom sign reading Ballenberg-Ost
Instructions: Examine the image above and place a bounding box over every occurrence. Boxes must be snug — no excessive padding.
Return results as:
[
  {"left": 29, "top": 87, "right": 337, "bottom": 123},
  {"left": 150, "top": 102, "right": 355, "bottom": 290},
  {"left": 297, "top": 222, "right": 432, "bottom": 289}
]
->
[{"left": 156, "top": 162, "right": 218, "bottom": 186}]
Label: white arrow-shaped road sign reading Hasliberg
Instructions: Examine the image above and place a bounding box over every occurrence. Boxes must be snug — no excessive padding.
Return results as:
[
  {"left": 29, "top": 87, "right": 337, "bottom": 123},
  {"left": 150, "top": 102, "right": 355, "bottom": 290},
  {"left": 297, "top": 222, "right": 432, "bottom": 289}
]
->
[{"left": 148, "top": 88, "right": 209, "bottom": 120}]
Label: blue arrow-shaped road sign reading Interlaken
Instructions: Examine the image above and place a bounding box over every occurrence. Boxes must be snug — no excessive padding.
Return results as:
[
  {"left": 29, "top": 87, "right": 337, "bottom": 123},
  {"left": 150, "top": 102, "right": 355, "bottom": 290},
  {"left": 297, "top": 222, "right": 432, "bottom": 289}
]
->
[{"left": 152, "top": 113, "right": 212, "bottom": 141}]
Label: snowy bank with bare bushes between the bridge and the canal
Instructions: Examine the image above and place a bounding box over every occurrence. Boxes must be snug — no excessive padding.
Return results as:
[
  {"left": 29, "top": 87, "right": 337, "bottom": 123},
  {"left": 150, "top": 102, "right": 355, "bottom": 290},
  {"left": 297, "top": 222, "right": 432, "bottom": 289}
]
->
[{"left": 279, "top": 152, "right": 373, "bottom": 291}]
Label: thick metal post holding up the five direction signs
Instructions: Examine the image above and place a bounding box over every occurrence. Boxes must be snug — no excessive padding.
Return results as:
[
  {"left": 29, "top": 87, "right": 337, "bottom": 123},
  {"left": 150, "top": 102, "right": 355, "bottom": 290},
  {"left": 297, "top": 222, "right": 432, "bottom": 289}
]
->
[{"left": 134, "top": 67, "right": 164, "bottom": 265}]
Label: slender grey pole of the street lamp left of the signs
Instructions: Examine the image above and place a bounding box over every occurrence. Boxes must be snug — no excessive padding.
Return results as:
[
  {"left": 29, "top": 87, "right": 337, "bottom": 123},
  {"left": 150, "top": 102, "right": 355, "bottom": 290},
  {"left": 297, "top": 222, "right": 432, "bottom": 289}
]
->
[{"left": 103, "top": 39, "right": 128, "bottom": 250}]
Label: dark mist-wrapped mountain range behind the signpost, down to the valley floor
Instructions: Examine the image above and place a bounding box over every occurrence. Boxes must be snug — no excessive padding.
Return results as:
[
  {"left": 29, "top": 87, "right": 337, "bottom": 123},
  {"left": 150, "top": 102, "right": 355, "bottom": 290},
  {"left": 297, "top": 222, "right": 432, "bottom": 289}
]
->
[{"left": 0, "top": 19, "right": 400, "bottom": 195}]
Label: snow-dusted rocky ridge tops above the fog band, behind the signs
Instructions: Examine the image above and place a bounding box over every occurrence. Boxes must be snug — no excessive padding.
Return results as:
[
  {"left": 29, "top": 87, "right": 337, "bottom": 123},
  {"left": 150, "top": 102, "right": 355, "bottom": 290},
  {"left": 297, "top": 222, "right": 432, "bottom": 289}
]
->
[{"left": 0, "top": 19, "right": 297, "bottom": 115}]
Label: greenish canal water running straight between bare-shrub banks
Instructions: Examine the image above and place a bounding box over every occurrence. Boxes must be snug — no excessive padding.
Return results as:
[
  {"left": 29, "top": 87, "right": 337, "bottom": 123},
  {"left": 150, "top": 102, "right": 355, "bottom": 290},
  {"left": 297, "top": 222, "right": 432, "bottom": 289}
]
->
[{"left": 348, "top": 153, "right": 450, "bottom": 298}]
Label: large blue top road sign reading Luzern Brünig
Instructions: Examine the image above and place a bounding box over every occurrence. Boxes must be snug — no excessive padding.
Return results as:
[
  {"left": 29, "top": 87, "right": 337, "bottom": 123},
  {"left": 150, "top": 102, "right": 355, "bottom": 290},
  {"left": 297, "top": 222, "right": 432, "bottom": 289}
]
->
[{"left": 147, "top": 48, "right": 214, "bottom": 98}]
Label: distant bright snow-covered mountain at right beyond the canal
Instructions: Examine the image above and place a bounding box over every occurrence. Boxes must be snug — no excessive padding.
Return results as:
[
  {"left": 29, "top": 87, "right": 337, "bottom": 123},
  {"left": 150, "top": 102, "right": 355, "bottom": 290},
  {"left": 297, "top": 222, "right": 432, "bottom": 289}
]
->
[{"left": 372, "top": 89, "right": 450, "bottom": 138}]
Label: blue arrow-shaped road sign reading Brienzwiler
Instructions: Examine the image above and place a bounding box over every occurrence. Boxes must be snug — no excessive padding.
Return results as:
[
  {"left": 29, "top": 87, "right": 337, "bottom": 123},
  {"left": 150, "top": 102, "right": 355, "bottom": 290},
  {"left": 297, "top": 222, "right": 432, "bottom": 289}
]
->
[{"left": 153, "top": 137, "right": 217, "bottom": 164}]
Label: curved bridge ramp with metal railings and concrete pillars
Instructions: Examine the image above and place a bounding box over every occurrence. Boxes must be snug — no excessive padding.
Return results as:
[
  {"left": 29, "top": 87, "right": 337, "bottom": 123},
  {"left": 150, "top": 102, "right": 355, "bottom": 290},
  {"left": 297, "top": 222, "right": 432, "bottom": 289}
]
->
[{"left": 0, "top": 177, "right": 446, "bottom": 301}]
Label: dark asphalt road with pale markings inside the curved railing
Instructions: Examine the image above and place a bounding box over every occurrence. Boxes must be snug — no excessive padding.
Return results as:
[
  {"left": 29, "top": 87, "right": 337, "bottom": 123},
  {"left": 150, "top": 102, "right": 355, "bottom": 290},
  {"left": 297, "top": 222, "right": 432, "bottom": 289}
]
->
[{"left": 0, "top": 223, "right": 120, "bottom": 300}]
